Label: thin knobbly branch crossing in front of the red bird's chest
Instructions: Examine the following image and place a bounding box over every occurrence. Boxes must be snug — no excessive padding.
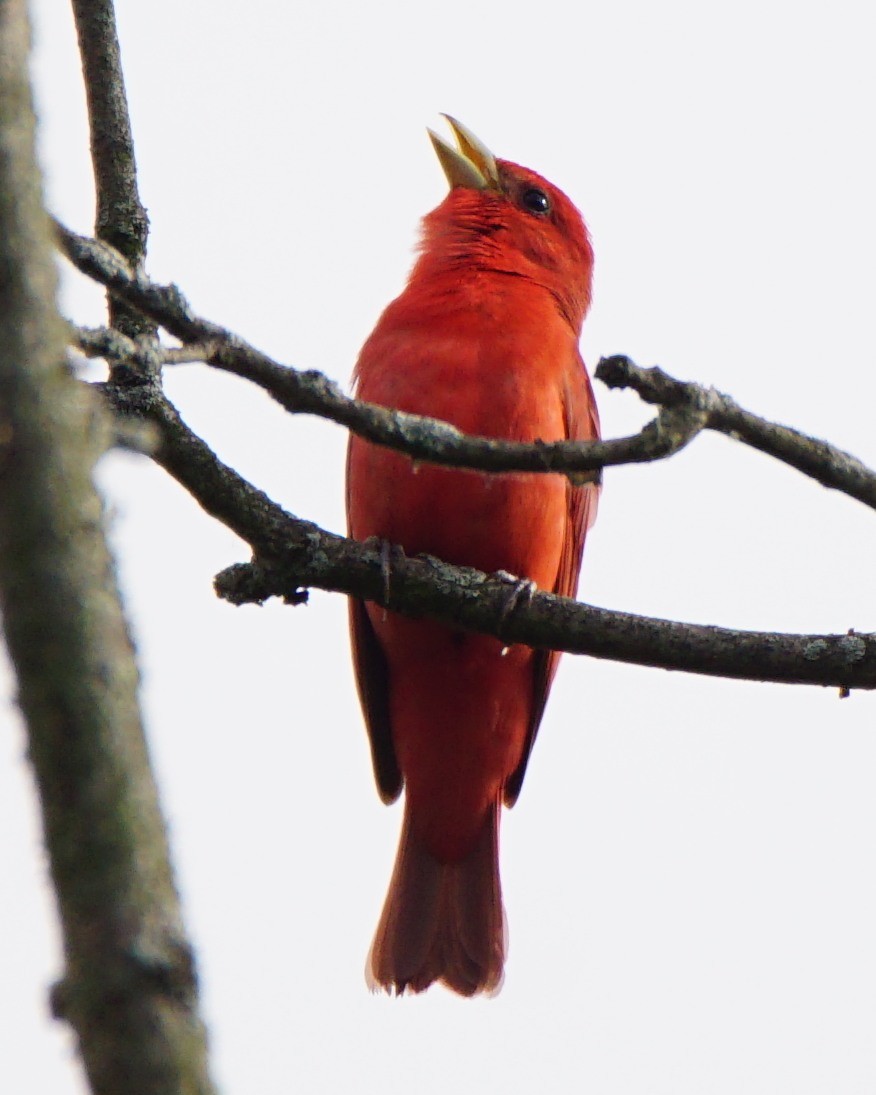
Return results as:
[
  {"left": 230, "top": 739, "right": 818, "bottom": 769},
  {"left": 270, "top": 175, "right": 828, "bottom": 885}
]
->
[{"left": 57, "top": 224, "right": 876, "bottom": 508}]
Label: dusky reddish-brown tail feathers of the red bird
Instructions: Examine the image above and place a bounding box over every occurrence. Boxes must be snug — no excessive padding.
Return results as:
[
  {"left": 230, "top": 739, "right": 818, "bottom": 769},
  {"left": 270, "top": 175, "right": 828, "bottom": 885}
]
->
[{"left": 366, "top": 803, "right": 506, "bottom": 996}]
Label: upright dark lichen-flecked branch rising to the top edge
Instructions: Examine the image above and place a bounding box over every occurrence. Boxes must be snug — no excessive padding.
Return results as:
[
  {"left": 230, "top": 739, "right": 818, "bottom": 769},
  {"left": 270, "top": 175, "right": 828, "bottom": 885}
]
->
[{"left": 72, "top": 0, "right": 155, "bottom": 337}]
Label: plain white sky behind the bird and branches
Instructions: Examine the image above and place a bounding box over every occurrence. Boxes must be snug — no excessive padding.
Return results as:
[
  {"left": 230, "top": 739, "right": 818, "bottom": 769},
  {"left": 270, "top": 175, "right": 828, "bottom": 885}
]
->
[{"left": 0, "top": 0, "right": 876, "bottom": 1095}]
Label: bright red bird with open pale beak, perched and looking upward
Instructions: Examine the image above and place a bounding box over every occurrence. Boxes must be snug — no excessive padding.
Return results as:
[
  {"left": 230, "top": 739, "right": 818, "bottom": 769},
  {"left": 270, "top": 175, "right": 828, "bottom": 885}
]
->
[{"left": 347, "top": 118, "right": 599, "bottom": 996}]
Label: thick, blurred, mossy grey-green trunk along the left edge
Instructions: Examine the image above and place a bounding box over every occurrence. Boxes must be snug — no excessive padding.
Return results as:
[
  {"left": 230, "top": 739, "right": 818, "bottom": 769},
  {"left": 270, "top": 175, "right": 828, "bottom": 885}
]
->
[{"left": 0, "top": 0, "right": 212, "bottom": 1095}]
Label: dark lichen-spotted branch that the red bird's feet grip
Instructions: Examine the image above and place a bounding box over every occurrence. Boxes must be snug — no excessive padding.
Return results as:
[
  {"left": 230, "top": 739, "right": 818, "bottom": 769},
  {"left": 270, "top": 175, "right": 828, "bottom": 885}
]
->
[{"left": 90, "top": 383, "right": 876, "bottom": 689}]
